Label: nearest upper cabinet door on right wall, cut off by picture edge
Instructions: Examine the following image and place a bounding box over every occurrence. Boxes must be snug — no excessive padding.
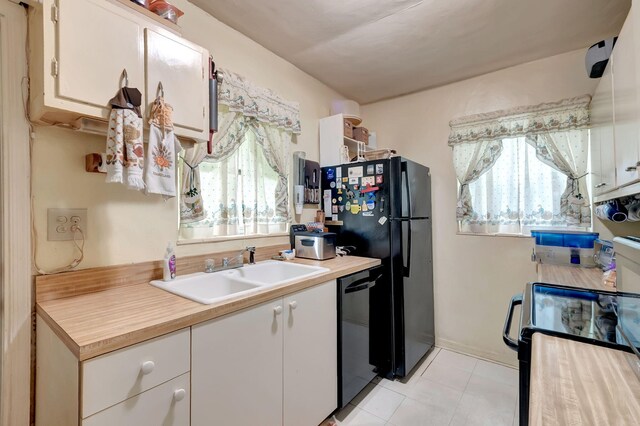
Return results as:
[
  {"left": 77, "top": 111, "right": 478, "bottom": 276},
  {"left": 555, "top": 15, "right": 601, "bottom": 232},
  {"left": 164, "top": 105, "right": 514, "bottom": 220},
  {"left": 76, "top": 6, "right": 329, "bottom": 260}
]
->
[{"left": 611, "top": 6, "right": 640, "bottom": 186}]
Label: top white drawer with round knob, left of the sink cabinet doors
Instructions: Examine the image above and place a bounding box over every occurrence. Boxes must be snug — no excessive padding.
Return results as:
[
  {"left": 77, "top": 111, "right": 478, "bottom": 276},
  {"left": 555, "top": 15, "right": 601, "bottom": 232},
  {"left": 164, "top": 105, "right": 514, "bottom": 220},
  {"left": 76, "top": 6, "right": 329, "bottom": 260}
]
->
[{"left": 81, "top": 328, "right": 191, "bottom": 418}]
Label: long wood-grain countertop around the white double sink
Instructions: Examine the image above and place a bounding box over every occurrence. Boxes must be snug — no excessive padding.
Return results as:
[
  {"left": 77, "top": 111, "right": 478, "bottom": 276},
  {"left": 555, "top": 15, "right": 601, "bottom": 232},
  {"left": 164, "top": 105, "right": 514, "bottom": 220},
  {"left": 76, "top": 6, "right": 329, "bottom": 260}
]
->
[{"left": 36, "top": 256, "right": 380, "bottom": 361}]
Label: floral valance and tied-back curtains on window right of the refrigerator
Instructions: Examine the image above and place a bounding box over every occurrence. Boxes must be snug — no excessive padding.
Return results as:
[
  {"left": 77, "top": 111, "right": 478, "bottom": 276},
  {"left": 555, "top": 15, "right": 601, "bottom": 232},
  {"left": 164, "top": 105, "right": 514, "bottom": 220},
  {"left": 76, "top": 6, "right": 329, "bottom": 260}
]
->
[{"left": 449, "top": 95, "right": 591, "bottom": 231}]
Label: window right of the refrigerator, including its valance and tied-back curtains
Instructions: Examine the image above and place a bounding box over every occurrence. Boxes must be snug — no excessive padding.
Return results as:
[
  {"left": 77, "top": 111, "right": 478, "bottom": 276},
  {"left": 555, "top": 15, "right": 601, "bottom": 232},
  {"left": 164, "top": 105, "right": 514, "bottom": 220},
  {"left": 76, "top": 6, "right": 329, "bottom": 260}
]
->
[{"left": 448, "top": 95, "right": 591, "bottom": 235}]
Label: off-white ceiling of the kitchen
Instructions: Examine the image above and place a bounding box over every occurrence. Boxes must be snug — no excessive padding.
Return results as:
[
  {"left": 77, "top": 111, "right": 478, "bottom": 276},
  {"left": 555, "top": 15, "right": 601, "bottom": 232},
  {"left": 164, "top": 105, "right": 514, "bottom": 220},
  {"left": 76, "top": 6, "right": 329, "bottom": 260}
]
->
[{"left": 191, "top": 0, "right": 631, "bottom": 104}]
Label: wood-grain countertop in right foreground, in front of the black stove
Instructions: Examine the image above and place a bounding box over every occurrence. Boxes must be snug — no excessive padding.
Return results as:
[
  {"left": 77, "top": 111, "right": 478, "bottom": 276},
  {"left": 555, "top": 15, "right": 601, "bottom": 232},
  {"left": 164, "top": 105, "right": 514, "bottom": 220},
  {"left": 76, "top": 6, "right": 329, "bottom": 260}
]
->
[{"left": 529, "top": 333, "right": 640, "bottom": 426}]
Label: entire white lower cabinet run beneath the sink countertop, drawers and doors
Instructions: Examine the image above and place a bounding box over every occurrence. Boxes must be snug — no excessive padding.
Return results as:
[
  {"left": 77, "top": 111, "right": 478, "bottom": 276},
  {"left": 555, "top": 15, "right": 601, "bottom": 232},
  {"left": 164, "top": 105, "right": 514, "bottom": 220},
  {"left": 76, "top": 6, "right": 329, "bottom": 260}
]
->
[{"left": 36, "top": 280, "right": 337, "bottom": 426}]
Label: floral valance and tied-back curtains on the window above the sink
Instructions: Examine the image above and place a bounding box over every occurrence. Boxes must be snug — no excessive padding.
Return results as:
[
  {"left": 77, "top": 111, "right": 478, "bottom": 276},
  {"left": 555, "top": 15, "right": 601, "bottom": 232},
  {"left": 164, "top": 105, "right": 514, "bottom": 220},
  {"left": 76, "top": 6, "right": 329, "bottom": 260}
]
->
[{"left": 180, "top": 70, "right": 300, "bottom": 236}]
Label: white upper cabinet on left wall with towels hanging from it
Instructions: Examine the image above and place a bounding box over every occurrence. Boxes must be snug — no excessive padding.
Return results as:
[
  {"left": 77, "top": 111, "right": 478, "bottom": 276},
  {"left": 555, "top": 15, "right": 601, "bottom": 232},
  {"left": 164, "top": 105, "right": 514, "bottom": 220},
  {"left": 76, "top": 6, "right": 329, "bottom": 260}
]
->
[{"left": 29, "top": 0, "right": 209, "bottom": 140}]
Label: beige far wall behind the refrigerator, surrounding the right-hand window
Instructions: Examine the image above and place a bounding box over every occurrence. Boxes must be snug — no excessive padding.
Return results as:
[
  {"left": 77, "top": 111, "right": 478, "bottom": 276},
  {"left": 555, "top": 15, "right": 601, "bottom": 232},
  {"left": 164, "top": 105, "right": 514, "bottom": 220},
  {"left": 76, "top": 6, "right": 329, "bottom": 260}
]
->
[{"left": 363, "top": 50, "right": 598, "bottom": 365}]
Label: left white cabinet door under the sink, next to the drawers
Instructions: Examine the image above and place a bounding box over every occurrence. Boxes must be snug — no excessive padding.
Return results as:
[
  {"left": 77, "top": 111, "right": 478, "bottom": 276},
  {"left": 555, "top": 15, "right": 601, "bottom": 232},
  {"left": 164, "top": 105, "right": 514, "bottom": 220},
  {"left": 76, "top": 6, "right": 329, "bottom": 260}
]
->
[{"left": 191, "top": 299, "right": 282, "bottom": 426}]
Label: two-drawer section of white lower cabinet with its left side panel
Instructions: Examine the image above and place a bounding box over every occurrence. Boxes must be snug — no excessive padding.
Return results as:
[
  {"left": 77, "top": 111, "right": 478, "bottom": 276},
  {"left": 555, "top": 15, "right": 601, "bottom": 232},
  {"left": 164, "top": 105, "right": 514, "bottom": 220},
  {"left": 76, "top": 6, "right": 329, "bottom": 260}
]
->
[{"left": 36, "top": 316, "right": 191, "bottom": 426}]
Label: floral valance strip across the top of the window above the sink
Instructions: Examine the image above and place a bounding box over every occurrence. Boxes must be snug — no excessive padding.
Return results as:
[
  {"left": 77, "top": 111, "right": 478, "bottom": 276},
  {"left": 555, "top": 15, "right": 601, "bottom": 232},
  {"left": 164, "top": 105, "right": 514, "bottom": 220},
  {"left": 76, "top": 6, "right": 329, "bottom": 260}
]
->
[{"left": 218, "top": 70, "right": 301, "bottom": 135}]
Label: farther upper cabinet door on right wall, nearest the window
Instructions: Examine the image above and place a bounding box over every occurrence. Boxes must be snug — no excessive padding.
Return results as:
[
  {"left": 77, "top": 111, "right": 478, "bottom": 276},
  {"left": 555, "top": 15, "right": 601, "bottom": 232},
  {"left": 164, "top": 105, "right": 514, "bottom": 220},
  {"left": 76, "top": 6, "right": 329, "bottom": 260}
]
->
[{"left": 591, "top": 62, "right": 616, "bottom": 195}]
